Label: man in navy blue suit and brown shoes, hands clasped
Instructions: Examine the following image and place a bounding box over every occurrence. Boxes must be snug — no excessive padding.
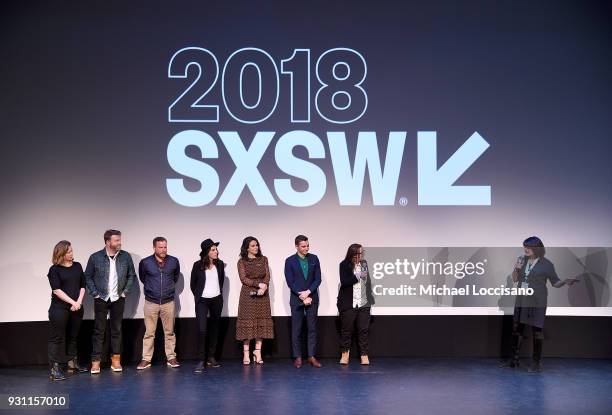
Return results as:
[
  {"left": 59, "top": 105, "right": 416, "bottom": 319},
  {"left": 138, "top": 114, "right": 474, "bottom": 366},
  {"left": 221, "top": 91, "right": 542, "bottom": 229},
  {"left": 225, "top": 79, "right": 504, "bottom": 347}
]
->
[{"left": 285, "top": 235, "right": 321, "bottom": 368}]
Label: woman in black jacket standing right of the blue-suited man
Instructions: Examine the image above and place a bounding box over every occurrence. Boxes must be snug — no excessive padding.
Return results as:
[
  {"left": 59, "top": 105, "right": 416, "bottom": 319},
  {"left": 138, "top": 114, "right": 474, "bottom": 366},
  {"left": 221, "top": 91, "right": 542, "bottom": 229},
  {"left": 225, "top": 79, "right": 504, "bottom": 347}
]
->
[{"left": 337, "top": 244, "right": 374, "bottom": 365}]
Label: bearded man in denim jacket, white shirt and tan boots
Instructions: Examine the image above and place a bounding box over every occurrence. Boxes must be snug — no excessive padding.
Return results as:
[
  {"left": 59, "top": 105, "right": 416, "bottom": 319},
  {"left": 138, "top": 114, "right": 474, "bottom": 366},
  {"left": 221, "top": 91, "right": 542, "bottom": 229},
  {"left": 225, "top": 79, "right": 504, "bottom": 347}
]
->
[{"left": 85, "top": 229, "right": 136, "bottom": 374}]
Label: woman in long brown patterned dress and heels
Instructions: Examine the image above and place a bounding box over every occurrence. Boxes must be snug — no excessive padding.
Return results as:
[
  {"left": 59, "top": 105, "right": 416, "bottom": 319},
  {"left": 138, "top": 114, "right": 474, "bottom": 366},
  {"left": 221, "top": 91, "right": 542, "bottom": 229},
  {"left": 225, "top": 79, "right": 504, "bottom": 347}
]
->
[{"left": 236, "top": 236, "right": 274, "bottom": 365}]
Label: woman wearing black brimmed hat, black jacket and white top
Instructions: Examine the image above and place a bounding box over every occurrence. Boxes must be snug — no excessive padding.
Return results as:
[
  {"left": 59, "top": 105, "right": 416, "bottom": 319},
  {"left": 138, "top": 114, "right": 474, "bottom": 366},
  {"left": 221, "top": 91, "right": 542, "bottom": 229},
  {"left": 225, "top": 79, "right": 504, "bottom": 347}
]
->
[{"left": 190, "top": 239, "right": 225, "bottom": 372}]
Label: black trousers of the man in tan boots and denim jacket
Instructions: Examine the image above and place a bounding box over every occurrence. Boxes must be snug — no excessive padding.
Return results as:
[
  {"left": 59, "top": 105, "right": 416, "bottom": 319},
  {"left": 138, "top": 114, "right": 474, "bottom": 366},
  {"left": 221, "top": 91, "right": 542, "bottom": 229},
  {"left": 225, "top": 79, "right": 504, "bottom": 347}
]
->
[{"left": 91, "top": 297, "right": 125, "bottom": 362}]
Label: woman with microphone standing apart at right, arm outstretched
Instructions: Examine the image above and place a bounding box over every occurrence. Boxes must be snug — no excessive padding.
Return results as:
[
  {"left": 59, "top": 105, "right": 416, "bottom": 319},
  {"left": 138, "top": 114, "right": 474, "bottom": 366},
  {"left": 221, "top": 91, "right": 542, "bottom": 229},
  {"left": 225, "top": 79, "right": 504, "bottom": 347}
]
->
[{"left": 503, "top": 236, "right": 576, "bottom": 372}]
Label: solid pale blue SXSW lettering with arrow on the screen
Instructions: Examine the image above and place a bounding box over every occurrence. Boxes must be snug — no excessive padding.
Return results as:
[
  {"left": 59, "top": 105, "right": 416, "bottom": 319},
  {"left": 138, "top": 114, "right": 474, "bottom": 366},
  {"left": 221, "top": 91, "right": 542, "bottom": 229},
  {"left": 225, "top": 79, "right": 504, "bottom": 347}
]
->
[{"left": 166, "top": 130, "right": 491, "bottom": 207}]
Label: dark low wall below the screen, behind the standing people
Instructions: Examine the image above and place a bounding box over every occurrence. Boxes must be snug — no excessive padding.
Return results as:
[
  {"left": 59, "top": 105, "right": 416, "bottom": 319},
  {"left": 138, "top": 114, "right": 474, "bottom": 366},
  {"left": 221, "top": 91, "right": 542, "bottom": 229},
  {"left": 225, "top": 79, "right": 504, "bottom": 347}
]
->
[{"left": 0, "top": 315, "right": 612, "bottom": 366}]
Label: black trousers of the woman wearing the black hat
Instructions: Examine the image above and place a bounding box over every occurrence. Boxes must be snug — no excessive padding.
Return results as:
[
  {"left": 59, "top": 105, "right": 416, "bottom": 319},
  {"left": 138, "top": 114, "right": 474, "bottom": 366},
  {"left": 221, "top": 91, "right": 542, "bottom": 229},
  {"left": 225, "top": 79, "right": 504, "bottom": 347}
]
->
[{"left": 196, "top": 295, "right": 223, "bottom": 361}]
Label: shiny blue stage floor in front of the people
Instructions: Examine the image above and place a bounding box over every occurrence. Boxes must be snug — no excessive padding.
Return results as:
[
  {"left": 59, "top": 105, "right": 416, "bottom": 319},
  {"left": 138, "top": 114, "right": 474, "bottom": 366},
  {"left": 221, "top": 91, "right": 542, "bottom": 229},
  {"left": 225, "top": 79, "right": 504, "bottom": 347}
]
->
[{"left": 0, "top": 358, "right": 612, "bottom": 415}]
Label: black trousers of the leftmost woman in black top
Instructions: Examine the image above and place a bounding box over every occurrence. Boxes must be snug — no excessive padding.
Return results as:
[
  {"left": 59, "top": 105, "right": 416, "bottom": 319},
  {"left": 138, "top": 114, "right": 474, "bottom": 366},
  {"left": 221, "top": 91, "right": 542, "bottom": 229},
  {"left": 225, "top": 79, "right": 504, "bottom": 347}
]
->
[{"left": 47, "top": 303, "right": 83, "bottom": 364}]
